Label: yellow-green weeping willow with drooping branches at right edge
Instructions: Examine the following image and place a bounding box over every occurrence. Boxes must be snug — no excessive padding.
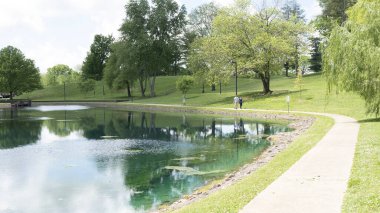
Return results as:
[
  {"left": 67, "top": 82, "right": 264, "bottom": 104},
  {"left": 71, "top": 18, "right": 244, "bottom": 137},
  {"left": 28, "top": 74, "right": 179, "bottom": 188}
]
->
[{"left": 323, "top": 0, "right": 380, "bottom": 115}]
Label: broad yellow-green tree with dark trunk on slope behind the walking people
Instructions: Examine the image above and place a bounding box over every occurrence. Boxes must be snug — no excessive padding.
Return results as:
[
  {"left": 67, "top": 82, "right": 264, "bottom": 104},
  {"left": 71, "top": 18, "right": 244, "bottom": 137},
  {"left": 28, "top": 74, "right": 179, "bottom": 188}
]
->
[{"left": 203, "top": 0, "right": 294, "bottom": 94}]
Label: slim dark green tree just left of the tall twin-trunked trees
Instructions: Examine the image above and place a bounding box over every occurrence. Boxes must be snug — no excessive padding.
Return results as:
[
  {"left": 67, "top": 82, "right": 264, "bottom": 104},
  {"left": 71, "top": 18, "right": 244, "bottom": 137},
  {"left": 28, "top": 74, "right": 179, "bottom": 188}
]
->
[{"left": 82, "top": 35, "right": 114, "bottom": 81}]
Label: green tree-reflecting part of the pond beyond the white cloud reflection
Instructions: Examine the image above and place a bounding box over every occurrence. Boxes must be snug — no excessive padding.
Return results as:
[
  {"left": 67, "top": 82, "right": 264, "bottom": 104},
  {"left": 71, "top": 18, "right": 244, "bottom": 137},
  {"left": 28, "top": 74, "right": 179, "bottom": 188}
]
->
[{"left": 0, "top": 108, "right": 288, "bottom": 210}]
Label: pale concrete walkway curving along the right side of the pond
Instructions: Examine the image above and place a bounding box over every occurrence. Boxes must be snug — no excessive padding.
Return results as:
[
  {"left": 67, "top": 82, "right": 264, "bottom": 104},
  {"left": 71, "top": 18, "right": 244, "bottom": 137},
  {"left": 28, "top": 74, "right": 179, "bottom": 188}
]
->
[{"left": 240, "top": 113, "right": 360, "bottom": 213}]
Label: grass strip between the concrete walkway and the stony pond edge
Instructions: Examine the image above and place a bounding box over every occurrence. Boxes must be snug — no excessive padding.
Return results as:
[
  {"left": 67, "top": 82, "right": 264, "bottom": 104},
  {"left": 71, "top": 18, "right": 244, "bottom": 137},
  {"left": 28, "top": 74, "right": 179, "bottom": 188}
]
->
[{"left": 176, "top": 117, "right": 333, "bottom": 213}]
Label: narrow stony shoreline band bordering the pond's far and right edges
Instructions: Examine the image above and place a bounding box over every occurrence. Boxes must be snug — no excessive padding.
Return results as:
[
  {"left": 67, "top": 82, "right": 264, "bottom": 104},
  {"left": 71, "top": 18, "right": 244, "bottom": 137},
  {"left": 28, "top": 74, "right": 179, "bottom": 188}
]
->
[{"left": 34, "top": 102, "right": 316, "bottom": 212}]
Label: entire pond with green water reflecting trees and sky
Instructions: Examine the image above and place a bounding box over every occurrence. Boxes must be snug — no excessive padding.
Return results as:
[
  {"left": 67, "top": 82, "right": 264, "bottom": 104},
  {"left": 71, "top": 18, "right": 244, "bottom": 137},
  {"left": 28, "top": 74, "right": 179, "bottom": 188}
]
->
[{"left": 0, "top": 106, "right": 289, "bottom": 212}]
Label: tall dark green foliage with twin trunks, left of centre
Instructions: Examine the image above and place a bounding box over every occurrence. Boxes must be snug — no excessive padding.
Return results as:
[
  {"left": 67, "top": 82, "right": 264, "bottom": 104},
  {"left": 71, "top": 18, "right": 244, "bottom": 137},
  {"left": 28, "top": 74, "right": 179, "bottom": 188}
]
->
[{"left": 120, "top": 0, "right": 186, "bottom": 96}]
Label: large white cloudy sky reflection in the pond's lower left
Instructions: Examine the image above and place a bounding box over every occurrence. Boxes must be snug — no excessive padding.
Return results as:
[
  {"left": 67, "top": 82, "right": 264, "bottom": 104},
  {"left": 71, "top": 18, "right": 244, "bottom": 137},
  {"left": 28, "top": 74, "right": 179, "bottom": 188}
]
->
[{"left": 0, "top": 128, "right": 135, "bottom": 212}]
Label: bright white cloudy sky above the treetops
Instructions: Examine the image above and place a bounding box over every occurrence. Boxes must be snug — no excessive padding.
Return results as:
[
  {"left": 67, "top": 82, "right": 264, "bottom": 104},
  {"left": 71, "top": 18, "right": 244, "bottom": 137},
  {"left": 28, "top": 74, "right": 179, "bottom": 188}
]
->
[{"left": 0, "top": 0, "right": 321, "bottom": 73}]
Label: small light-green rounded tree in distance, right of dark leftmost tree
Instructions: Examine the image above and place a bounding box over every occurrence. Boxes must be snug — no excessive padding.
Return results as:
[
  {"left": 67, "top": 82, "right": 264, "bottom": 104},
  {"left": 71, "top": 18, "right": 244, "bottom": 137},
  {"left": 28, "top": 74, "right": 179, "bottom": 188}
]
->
[{"left": 44, "top": 64, "right": 79, "bottom": 86}]
